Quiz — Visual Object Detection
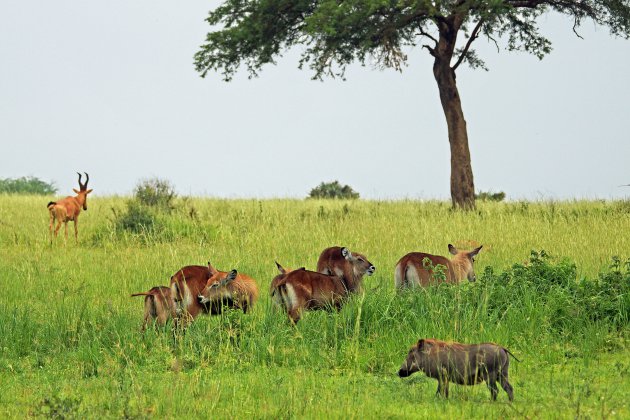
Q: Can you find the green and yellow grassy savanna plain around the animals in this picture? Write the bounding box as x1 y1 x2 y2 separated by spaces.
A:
0 195 630 418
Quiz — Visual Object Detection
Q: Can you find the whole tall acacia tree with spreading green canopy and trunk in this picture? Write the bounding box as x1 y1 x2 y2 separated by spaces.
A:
195 0 630 208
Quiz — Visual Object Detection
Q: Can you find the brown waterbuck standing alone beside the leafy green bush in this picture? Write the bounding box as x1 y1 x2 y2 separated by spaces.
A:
394 244 483 289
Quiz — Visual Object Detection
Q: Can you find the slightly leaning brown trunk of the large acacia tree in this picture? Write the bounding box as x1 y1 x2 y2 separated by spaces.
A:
431 16 475 210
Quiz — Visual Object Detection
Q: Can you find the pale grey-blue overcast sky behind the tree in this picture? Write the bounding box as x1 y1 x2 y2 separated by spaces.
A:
0 0 630 200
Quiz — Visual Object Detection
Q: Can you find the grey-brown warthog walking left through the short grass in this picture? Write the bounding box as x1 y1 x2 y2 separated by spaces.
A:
398 338 518 401
